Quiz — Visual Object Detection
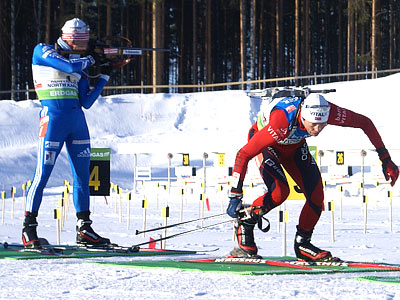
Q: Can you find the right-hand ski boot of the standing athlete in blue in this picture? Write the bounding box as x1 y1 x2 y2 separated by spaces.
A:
76 211 111 246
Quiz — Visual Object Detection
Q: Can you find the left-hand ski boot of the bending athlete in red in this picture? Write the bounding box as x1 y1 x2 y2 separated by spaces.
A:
231 209 262 258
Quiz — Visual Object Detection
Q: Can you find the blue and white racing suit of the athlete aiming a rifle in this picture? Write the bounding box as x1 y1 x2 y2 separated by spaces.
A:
25 44 109 212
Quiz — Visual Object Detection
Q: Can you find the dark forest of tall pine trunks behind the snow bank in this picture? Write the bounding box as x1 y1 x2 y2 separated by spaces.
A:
0 0 400 100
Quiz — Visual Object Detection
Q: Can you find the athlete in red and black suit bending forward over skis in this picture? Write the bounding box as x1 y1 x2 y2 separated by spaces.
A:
227 88 399 261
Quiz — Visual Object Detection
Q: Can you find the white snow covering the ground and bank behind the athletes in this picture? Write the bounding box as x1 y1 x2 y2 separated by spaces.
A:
0 74 400 299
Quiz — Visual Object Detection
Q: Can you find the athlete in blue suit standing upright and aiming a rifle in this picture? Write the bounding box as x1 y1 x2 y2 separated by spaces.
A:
22 18 110 248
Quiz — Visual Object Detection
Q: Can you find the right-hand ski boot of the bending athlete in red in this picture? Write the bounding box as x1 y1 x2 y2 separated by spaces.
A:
294 226 338 262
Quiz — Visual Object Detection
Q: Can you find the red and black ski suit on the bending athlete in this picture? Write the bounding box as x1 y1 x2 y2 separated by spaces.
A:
232 97 384 236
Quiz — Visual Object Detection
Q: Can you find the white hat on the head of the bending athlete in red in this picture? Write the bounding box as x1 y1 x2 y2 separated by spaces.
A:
301 93 331 123
